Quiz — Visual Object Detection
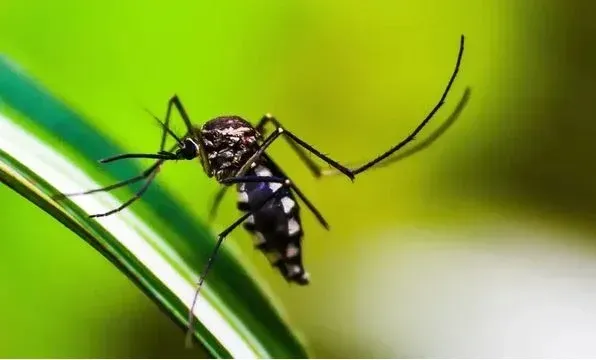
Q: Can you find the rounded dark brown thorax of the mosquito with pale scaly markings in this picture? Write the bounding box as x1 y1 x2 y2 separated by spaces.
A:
201 116 260 180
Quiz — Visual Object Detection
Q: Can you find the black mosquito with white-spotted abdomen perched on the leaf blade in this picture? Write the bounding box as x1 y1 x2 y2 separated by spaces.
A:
54 35 464 344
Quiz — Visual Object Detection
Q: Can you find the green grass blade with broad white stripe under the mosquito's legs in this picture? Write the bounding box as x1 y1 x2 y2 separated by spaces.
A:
0 59 307 358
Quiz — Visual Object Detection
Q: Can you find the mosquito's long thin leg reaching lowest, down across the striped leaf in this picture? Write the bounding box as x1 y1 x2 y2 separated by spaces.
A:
186 178 291 347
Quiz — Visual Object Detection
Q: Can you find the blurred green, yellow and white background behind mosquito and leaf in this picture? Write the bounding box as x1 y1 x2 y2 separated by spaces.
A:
0 0 596 357
